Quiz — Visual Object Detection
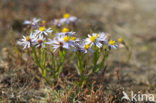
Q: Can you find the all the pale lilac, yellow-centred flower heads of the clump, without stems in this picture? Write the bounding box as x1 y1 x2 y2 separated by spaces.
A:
17 13 122 53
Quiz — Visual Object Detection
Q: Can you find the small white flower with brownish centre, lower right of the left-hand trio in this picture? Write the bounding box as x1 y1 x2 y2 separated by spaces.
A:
33 35 46 47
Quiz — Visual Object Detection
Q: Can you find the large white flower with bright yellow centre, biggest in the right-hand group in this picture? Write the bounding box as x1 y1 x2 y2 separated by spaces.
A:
85 33 102 48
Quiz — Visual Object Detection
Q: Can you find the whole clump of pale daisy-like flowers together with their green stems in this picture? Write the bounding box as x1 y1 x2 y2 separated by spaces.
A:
17 13 125 81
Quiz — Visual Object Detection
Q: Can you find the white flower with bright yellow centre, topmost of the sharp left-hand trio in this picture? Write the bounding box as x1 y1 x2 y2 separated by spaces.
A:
35 26 53 36
